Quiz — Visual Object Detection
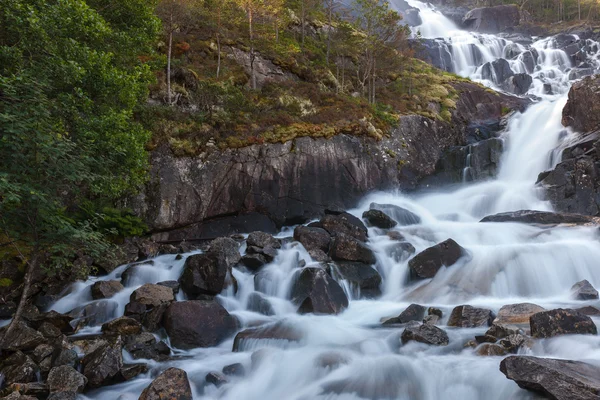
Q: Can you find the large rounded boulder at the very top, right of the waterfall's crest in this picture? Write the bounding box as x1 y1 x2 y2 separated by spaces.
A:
463 4 521 33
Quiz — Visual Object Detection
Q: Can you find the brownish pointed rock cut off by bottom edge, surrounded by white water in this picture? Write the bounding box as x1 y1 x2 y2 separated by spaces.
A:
139 368 193 400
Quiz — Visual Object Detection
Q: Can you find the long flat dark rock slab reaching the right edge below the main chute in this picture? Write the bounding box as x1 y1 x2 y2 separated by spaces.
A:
480 210 600 225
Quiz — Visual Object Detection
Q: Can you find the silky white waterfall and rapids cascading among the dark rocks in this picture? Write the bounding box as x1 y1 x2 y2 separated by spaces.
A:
53 1 600 400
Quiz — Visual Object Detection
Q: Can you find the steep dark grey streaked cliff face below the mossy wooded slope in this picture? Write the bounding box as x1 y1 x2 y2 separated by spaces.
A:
135 83 526 241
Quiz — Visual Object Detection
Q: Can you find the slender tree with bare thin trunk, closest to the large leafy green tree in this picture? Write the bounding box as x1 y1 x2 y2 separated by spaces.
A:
156 0 195 105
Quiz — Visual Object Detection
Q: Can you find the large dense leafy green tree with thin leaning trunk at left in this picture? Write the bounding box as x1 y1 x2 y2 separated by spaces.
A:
0 0 159 349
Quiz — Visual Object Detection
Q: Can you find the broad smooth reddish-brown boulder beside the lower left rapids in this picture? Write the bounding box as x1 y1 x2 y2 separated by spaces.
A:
163 300 238 349
